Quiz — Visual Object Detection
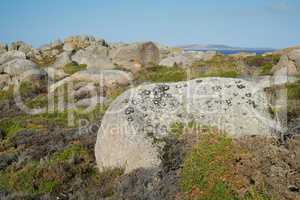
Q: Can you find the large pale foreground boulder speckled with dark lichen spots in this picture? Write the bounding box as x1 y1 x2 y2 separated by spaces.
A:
95 78 279 172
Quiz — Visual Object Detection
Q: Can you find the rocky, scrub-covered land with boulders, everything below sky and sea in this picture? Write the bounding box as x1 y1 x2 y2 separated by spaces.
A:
0 36 300 200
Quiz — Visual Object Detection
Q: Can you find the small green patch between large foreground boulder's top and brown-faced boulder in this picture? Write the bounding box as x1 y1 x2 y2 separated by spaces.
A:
136 66 187 82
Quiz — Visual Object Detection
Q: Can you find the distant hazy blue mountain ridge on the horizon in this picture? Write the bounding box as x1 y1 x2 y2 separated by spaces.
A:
176 44 275 51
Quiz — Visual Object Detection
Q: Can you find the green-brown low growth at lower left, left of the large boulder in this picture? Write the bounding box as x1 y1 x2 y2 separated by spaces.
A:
0 144 92 197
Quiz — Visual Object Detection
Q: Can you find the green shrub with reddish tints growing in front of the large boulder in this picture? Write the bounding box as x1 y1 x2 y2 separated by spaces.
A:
180 134 235 200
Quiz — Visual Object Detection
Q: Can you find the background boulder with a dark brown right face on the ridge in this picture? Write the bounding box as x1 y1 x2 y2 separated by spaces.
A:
112 42 160 69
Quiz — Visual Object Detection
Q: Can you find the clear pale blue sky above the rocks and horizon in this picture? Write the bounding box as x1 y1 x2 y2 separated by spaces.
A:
0 0 300 48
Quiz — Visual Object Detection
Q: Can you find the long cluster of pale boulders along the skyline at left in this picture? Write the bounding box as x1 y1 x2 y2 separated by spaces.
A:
0 35 216 90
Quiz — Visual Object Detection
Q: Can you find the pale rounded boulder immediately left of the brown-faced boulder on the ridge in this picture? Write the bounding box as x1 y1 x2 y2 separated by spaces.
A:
72 45 115 69
